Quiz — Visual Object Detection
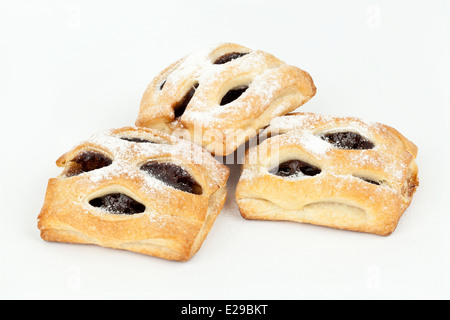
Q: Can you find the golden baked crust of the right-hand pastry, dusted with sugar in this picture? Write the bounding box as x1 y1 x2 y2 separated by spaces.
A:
236 113 419 235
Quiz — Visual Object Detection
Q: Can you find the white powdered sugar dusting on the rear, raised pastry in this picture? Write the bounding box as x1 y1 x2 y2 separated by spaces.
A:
141 44 297 127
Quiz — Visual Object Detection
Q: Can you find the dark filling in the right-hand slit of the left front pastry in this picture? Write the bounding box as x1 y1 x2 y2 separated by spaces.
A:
141 161 203 194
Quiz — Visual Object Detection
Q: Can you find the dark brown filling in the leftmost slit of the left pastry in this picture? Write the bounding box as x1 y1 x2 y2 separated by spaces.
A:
66 151 112 177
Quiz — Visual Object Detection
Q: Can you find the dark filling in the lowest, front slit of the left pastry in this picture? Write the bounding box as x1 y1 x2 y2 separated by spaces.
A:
89 193 145 214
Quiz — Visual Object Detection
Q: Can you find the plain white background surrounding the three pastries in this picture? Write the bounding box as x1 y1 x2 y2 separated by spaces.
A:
0 0 450 299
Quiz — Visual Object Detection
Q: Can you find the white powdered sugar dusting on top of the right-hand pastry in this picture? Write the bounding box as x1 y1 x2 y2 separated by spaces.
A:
243 113 411 192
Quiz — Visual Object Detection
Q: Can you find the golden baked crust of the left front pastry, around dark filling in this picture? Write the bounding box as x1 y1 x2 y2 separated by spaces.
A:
38 127 229 261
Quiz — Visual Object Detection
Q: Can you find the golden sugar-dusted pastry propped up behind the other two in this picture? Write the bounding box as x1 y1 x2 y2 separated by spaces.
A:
136 43 316 156
